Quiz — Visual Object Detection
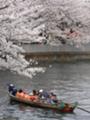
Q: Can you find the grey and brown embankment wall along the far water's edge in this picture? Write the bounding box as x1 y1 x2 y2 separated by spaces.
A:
22 44 90 62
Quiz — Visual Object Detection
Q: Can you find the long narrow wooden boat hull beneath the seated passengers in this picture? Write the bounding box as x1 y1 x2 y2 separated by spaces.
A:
9 94 77 113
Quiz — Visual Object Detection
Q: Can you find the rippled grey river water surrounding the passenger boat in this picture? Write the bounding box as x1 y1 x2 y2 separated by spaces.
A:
0 61 90 120
